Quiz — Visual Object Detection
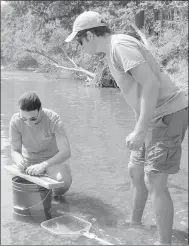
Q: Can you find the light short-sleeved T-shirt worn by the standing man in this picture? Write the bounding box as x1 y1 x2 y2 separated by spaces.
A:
108 34 188 120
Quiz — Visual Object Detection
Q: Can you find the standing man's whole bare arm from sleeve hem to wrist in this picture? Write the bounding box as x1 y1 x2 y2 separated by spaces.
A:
130 63 160 133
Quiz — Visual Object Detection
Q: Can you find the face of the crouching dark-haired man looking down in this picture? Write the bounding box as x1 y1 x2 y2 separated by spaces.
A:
20 109 40 126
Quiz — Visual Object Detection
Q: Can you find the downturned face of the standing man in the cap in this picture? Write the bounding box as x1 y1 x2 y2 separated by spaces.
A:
77 32 97 54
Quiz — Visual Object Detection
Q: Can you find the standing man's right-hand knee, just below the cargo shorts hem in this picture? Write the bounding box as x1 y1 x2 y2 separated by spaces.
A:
144 173 168 196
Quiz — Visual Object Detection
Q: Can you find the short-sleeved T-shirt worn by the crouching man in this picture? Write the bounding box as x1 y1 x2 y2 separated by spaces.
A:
9 108 67 163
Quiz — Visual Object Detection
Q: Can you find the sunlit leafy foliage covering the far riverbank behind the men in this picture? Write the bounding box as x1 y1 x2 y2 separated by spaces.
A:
1 1 188 91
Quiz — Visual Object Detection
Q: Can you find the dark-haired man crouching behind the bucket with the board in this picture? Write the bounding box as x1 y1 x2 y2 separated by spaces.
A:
9 92 72 197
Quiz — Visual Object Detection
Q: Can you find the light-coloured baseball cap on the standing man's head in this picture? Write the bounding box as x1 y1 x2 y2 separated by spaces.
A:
65 11 107 42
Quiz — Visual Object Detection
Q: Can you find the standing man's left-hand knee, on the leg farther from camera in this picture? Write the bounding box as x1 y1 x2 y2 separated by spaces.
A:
128 162 144 186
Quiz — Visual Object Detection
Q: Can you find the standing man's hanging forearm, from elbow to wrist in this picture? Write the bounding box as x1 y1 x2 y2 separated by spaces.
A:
135 84 159 132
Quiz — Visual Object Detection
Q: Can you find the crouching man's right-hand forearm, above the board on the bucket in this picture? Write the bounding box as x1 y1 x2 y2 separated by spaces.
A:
44 151 71 168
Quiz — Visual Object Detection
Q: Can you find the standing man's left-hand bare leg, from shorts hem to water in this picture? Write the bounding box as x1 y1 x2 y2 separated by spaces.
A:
128 162 148 224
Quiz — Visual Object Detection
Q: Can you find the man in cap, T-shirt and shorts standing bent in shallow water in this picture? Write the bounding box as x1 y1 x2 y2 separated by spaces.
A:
65 11 188 245
